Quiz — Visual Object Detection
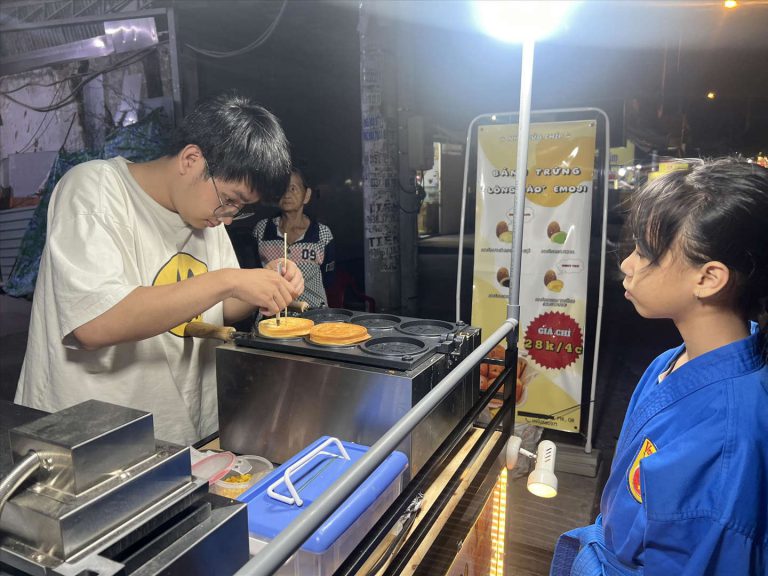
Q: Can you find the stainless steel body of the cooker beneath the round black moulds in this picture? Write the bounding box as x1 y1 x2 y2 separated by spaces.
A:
216 328 479 476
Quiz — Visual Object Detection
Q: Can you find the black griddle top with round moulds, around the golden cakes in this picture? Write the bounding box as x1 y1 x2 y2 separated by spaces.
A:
235 308 458 370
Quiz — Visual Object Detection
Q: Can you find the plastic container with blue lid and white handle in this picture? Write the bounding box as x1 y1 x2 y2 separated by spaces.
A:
238 436 408 576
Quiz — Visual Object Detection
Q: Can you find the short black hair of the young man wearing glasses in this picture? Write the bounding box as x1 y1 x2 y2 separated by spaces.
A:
168 92 291 204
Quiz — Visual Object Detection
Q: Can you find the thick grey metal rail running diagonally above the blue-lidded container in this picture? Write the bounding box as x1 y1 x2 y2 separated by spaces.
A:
237 319 517 576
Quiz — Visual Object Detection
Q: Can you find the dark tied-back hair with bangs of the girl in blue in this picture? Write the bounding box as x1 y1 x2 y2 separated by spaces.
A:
628 158 768 329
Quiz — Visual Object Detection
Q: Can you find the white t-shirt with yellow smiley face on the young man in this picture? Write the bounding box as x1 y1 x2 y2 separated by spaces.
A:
15 157 238 445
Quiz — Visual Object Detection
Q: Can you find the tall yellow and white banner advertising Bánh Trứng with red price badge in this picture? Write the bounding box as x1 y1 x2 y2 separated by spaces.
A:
472 120 597 432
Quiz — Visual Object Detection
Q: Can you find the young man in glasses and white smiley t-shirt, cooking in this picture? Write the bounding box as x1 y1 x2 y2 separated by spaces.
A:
16 95 304 444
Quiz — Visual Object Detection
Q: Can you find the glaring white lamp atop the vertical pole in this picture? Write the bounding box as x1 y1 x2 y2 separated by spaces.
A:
473 0 577 43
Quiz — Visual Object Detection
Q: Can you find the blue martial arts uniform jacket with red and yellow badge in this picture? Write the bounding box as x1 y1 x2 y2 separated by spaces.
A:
553 334 768 576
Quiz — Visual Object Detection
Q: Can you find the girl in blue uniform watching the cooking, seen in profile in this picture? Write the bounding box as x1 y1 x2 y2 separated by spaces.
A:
551 159 768 576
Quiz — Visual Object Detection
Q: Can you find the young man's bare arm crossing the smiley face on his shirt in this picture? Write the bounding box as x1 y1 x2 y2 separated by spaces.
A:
73 269 296 350
